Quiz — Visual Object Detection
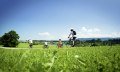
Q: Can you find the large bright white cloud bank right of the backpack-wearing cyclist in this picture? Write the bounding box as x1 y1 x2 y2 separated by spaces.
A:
77 27 120 38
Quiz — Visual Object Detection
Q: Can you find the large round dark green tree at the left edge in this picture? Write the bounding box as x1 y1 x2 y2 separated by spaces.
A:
1 30 19 47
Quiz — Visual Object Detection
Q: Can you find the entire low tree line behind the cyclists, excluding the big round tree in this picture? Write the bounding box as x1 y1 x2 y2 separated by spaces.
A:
29 38 120 47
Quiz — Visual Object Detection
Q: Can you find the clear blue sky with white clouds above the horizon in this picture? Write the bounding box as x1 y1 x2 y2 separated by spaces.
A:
0 0 120 40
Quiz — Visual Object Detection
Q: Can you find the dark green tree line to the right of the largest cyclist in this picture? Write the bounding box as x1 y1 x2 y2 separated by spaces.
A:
76 38 120 47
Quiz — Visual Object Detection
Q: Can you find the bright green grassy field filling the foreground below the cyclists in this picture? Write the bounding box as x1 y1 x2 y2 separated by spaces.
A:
0 45 120 72
